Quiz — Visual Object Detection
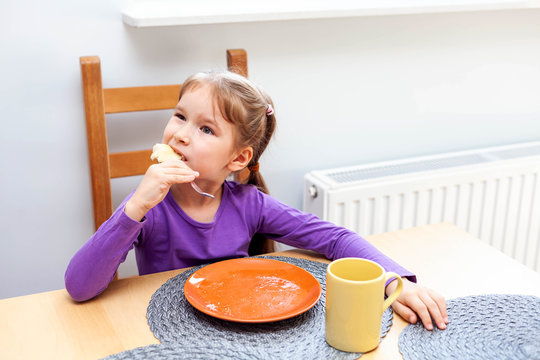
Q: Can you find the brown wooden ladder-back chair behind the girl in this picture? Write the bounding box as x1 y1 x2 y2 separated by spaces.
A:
80 49 273 262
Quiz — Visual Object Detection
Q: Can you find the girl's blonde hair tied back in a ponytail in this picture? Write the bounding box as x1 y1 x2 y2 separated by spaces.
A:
179 71 276 194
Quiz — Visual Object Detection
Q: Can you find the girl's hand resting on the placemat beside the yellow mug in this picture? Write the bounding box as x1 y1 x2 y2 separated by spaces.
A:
386 278 448 330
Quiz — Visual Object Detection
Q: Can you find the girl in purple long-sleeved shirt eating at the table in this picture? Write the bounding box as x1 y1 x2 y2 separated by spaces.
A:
65 72 448 329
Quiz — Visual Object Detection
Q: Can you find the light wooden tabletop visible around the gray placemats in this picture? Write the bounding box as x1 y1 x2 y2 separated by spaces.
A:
0 223 540 360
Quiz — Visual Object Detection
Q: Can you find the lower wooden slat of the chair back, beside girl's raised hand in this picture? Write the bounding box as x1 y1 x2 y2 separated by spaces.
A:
109 150 154 178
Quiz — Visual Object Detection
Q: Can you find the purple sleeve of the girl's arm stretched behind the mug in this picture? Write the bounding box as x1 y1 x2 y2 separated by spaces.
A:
258 192 416 282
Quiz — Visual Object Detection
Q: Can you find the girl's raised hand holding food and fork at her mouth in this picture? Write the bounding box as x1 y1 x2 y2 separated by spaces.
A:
124 160 199 221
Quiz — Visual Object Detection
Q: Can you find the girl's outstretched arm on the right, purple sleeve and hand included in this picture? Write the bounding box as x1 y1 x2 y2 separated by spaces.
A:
255 193 448 330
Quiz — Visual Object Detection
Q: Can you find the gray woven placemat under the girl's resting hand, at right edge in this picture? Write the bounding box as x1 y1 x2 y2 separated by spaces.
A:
399 294 540 360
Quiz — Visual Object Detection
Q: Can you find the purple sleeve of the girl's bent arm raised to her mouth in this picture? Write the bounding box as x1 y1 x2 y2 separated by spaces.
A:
64 197 146 301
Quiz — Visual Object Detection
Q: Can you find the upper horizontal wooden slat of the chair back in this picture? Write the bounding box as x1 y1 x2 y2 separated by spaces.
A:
103 84 182 114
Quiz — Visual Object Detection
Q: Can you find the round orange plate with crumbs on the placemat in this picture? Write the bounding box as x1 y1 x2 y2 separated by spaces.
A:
184 258 321 323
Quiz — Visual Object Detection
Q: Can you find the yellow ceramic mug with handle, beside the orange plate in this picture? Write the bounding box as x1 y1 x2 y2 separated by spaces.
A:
326 258 403 352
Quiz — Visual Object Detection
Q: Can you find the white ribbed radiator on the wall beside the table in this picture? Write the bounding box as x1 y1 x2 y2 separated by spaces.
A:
304 142 540 271
